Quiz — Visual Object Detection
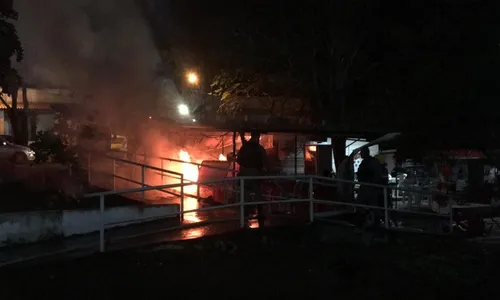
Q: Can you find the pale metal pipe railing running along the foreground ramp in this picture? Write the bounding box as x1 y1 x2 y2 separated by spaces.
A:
86 173 453 252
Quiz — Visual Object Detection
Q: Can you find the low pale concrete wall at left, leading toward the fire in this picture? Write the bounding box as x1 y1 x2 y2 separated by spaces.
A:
0 204 179 247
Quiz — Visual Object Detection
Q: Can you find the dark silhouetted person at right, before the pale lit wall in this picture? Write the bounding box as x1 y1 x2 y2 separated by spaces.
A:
356 147 384 226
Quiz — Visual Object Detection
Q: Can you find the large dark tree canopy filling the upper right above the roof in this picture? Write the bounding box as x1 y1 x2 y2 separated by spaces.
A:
150 0 500 163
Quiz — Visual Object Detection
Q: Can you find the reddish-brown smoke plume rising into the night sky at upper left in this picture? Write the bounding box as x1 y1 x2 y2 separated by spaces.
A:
15 0 160 128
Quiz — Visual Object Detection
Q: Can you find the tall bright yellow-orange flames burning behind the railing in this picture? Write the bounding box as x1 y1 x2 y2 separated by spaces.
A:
179 150 200 222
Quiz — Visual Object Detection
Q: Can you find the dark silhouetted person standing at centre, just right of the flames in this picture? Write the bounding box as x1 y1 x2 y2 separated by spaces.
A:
237 132 268 227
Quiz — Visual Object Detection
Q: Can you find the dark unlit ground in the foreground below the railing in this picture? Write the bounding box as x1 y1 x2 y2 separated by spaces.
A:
0 226 500 300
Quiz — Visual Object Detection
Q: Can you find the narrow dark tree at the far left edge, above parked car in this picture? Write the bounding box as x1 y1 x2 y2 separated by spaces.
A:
0 0 27 143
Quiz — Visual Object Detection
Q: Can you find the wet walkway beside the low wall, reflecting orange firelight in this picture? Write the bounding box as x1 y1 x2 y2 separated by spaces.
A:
0 209 298 267
